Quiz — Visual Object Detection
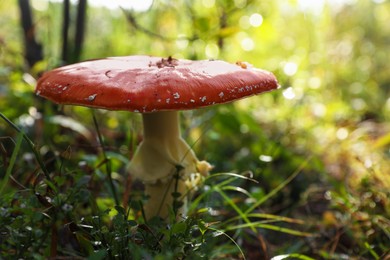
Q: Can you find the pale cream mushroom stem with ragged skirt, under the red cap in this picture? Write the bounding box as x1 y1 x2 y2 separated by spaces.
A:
129 111 208 218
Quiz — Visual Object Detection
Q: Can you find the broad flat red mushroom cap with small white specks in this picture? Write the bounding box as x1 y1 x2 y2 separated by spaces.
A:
36 56 278 113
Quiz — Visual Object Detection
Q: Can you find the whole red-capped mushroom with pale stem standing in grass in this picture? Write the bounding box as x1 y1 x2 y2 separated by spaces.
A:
36 56 278 218
